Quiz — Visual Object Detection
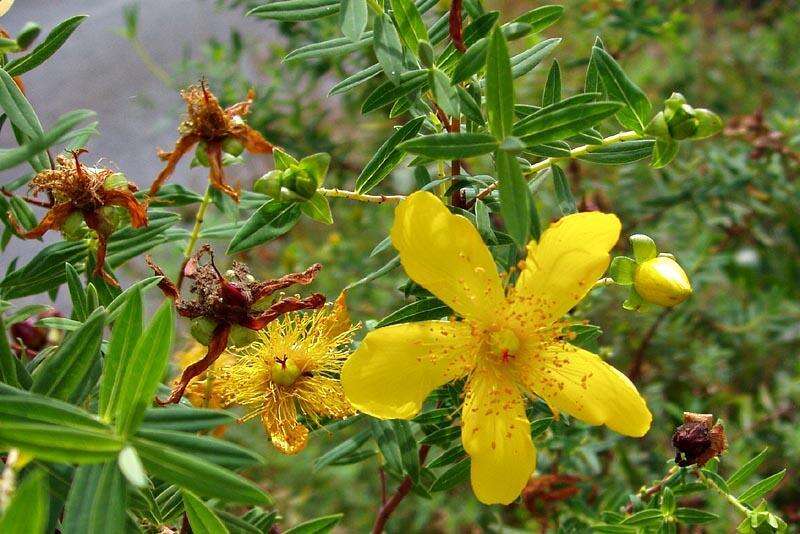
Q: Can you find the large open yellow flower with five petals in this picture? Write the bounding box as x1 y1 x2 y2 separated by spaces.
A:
342 192 652 504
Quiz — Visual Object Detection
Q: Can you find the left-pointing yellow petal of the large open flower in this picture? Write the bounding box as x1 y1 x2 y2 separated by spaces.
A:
342 321 478 419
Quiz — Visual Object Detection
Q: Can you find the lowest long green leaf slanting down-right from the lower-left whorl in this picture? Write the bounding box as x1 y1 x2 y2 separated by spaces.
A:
131 438 272 505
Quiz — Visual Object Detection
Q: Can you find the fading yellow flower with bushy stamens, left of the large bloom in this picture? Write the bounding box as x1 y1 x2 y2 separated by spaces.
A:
218 298 358 454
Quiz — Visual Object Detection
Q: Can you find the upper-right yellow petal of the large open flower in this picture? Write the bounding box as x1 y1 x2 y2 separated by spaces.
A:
515 212 620 321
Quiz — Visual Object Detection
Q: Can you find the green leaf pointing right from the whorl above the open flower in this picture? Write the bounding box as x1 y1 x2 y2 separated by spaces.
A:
513 95 620 146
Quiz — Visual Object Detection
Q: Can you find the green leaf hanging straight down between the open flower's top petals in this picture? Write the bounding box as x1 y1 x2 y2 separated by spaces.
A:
495 150 531 248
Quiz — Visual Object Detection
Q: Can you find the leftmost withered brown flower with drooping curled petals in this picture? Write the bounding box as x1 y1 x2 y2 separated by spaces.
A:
9 149 147 285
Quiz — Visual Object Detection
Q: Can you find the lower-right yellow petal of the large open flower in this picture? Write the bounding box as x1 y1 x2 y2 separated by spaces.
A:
519 343 653 437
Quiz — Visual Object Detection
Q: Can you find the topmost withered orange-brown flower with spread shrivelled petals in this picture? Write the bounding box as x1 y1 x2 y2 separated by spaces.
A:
150 81 273 201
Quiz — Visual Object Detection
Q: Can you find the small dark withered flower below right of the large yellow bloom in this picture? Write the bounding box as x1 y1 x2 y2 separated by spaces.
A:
672 412 728 467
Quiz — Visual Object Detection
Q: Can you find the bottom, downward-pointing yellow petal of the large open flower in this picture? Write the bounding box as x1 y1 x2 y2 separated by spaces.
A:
461 368 536 504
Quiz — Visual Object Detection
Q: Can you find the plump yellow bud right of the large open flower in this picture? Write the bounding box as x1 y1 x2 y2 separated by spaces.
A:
633 255 692 307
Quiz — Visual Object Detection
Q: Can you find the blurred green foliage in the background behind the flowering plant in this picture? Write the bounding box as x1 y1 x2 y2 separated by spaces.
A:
112 0 800 532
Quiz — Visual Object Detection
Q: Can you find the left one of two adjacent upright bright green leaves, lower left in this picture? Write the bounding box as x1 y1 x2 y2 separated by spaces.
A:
98 290 144 421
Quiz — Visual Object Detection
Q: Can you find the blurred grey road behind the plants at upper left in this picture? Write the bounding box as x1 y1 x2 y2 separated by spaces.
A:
0 0 269 280
